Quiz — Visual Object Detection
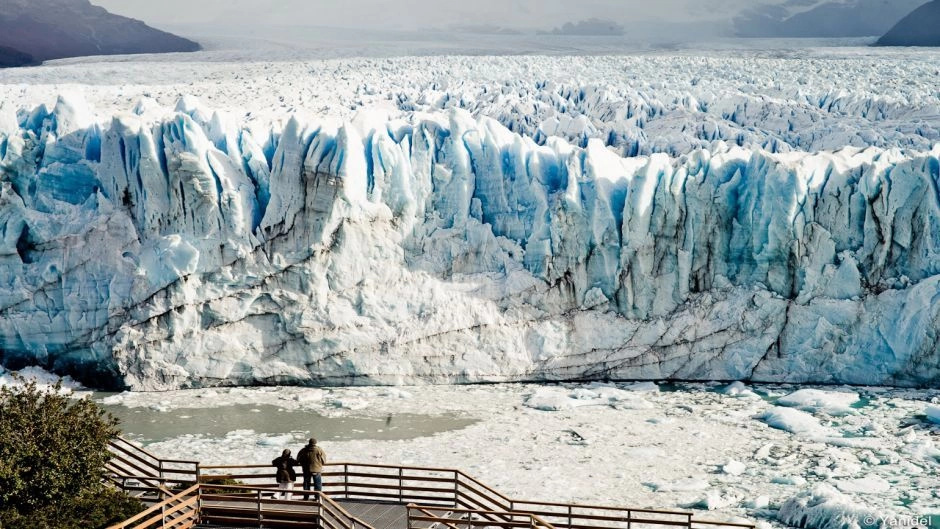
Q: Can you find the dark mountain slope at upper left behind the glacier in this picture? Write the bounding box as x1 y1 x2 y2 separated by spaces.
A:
0 0 200 66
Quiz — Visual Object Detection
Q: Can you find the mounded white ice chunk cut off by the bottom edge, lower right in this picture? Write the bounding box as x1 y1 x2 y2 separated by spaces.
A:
777 484 882 529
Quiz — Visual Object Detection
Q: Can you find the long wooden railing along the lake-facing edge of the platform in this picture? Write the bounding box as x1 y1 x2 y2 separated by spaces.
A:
108 440 754 529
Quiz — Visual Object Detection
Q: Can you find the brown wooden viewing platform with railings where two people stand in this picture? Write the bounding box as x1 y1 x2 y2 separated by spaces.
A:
106 439 754 529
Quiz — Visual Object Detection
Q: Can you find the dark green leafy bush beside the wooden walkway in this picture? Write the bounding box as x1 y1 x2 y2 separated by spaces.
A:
0 374 142 529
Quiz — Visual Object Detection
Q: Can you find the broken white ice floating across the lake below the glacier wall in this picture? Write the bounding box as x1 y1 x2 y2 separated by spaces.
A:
0 370 940 529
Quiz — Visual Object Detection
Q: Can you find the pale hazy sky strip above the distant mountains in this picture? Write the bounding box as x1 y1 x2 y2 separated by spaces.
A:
92 0 784 29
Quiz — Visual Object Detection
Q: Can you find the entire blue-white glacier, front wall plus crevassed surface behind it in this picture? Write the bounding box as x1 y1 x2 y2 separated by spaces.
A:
0 50 940 390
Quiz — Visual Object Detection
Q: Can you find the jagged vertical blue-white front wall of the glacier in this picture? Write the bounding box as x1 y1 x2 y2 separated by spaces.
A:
0 97 940 390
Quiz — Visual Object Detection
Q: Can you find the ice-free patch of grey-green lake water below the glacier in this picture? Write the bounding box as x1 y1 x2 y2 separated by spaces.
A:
96 394 477 444
